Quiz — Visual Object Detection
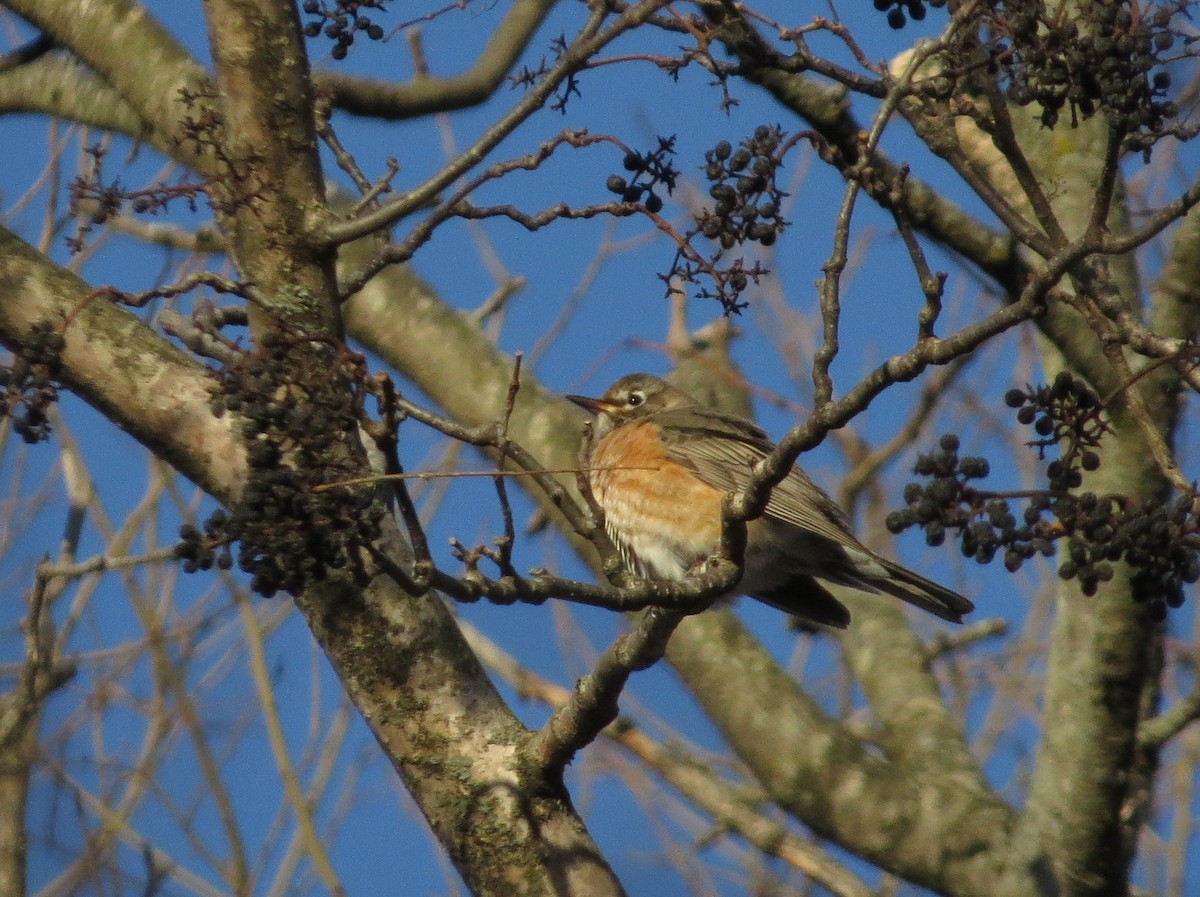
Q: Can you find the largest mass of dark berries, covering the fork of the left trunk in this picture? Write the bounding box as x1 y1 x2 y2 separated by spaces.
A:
179 335 384 596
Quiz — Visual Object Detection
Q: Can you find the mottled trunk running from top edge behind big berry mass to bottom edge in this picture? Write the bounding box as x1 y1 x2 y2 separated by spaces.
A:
193 0 620 897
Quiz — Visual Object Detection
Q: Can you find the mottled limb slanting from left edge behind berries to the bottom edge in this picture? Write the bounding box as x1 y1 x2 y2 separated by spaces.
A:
0 182 620 895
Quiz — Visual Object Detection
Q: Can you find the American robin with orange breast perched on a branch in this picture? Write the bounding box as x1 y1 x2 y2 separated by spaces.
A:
566 374 974 628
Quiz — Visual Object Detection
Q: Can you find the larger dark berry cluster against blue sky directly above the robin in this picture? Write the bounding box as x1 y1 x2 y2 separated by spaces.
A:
696 125 787 249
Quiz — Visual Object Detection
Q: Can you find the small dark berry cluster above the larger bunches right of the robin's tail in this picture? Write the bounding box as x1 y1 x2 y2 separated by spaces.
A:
1004 371 1109 493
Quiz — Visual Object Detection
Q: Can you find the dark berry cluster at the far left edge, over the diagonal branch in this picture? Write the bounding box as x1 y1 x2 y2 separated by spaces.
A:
0 321 66 445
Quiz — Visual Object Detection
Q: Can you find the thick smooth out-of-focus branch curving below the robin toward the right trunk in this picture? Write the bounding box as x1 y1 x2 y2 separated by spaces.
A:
667 610 1014 895
